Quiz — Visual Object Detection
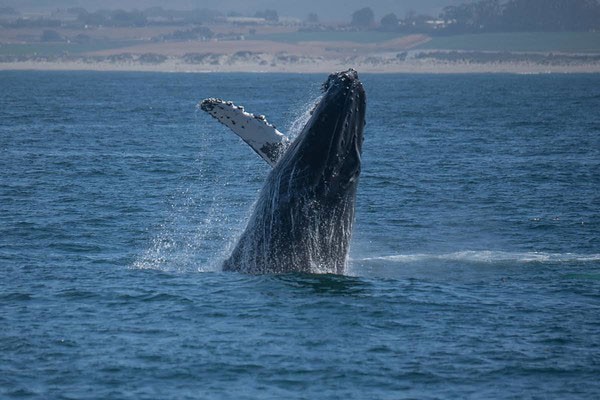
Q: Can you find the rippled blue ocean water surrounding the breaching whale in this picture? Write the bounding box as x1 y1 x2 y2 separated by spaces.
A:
0 72 600 399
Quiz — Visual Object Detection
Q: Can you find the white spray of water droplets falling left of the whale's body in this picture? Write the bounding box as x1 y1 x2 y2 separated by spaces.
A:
132 115 255 272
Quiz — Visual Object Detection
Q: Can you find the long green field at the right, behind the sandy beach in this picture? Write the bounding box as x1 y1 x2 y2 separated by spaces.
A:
416 32 600 53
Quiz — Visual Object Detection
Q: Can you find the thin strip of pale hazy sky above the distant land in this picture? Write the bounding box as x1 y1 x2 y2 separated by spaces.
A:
0 0 466 21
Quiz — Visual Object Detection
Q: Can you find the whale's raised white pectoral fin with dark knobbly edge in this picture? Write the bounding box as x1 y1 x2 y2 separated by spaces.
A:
200 98 289 166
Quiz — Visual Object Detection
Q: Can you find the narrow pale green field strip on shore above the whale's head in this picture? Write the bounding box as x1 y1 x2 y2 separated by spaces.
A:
248 31 406 43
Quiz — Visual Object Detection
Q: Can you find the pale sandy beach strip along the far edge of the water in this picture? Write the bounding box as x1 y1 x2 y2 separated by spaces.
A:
0 54 600 74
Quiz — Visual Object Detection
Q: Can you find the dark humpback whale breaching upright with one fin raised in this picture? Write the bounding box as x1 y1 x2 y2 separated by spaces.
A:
200 69 366 274
